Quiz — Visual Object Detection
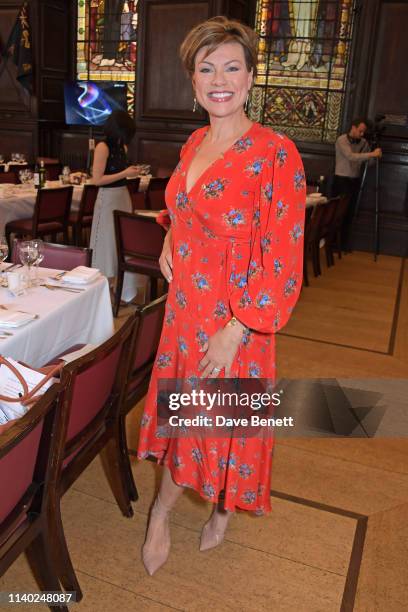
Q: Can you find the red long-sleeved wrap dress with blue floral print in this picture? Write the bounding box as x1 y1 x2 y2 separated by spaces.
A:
138 123 306 514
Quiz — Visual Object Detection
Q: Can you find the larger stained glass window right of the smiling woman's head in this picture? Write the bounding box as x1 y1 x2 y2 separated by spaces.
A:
250 0 354 142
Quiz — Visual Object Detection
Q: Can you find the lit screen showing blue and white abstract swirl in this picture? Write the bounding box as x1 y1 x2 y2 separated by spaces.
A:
64 81 127 125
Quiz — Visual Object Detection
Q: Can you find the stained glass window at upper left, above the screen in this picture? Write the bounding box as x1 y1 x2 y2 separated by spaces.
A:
77 0 137 114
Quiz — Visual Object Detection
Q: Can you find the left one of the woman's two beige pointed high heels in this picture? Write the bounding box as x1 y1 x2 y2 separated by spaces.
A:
142 495 170 576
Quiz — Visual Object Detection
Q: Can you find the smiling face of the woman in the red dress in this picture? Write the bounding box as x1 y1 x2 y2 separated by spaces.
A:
192 42 252 117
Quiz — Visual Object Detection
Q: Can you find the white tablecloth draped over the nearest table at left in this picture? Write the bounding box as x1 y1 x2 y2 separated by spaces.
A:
0 268 114 367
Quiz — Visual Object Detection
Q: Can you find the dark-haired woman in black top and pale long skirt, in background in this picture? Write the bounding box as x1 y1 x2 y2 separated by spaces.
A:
89 111 138 279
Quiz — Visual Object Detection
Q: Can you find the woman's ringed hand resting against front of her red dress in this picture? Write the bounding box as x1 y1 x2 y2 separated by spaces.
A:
198 323 244 378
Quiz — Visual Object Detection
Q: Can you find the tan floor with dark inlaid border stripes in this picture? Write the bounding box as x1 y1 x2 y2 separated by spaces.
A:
0 253 408 612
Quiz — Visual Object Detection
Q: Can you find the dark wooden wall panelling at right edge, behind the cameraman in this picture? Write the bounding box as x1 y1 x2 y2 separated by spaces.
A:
354 0 408 255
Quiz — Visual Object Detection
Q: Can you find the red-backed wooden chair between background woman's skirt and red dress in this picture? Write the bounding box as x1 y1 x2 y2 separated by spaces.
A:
113 210 166 316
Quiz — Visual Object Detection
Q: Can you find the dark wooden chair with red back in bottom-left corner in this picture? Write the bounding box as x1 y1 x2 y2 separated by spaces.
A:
0 384 68 612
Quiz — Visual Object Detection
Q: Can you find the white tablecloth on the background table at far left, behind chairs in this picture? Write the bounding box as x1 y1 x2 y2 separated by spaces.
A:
0 181 83 234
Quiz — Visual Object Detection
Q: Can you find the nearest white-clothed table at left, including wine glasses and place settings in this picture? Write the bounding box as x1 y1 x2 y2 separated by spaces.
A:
0 238 114 367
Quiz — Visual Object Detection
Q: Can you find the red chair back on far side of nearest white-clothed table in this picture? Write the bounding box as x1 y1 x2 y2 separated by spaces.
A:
11 238 92 271
